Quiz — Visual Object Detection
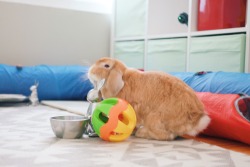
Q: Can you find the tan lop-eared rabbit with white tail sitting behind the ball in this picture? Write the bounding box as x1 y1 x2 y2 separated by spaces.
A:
88 58 210 140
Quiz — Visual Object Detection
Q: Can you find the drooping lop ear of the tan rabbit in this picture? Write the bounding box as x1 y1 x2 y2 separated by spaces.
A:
105 70 124 96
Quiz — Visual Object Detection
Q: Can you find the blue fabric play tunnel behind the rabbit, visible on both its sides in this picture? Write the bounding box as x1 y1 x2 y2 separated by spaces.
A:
0 64 250 100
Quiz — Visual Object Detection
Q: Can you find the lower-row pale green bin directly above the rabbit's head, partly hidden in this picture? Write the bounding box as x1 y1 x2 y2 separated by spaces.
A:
114 41 144 69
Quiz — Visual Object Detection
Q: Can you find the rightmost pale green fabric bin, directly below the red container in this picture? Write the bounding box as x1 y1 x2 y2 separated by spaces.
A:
189 34 246 72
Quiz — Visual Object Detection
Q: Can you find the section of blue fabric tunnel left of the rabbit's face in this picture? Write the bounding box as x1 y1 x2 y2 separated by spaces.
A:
0 64 92 100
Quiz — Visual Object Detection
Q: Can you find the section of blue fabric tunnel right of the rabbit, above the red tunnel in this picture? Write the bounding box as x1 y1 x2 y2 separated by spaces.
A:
170 72 250 95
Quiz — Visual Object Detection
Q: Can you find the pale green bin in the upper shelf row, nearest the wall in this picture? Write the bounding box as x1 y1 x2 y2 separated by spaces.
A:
115 0 147 38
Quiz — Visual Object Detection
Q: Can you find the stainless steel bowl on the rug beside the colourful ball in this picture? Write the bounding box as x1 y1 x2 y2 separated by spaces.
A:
50 116 90 139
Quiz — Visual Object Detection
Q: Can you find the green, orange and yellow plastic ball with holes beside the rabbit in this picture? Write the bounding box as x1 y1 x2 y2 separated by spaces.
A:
92 98 136 142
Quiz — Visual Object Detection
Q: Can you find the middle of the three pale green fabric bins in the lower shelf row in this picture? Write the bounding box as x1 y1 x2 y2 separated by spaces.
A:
147 38 187 72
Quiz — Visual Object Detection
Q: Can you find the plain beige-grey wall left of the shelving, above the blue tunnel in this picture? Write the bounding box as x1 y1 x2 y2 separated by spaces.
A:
0 1 111 65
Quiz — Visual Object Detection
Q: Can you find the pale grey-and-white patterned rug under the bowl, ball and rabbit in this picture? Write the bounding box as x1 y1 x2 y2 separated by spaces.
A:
0 106 250 167
